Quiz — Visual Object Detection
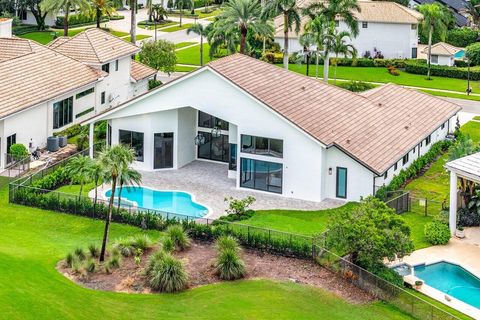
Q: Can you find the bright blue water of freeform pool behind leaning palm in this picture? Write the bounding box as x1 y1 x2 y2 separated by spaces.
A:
105 187 208 217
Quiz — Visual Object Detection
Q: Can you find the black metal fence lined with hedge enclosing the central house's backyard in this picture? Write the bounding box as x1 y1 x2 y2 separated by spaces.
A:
9 162 458 320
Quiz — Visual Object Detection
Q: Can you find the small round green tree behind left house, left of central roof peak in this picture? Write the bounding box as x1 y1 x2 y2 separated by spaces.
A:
138 40 177 74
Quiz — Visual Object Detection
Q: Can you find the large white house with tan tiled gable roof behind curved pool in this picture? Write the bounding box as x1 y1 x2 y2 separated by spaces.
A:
83 54 460 201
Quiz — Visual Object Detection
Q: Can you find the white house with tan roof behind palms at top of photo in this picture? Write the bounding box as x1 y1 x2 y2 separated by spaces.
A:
275 0 422 59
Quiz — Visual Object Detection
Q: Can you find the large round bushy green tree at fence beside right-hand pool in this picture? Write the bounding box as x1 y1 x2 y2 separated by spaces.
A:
327 197 413 271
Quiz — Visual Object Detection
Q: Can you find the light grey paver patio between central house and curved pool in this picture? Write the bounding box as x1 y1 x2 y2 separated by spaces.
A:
94 160 345 219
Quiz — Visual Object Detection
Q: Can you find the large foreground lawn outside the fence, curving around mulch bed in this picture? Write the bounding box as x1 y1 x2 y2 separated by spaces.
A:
0 188 411 320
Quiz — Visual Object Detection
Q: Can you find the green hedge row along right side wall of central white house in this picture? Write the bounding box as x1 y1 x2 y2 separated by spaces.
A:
375 140 452 200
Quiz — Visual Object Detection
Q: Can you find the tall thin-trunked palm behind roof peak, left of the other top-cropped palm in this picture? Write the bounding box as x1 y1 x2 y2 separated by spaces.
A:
263 0 301 70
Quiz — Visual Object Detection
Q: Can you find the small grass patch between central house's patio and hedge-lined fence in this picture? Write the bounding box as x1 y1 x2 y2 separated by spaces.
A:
241 202 357 235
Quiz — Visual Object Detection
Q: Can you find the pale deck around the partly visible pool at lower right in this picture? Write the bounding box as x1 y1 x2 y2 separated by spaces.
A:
388 228 480 319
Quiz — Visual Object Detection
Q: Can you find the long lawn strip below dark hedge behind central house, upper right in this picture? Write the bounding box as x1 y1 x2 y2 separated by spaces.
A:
284 63 480 93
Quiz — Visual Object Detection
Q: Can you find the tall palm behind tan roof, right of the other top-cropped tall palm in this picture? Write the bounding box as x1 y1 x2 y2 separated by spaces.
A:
304 0 360 82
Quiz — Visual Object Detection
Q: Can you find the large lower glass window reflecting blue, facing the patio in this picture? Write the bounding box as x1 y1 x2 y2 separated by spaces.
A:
240 158 283 193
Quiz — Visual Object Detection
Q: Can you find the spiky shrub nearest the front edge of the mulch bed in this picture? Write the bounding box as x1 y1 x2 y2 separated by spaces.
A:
148 254 188 292
